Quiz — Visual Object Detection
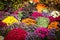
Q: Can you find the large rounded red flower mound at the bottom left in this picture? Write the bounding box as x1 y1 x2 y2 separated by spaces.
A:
4 28 27 40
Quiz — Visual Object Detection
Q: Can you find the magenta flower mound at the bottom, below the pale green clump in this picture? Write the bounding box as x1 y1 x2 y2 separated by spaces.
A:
34 27 48 38
